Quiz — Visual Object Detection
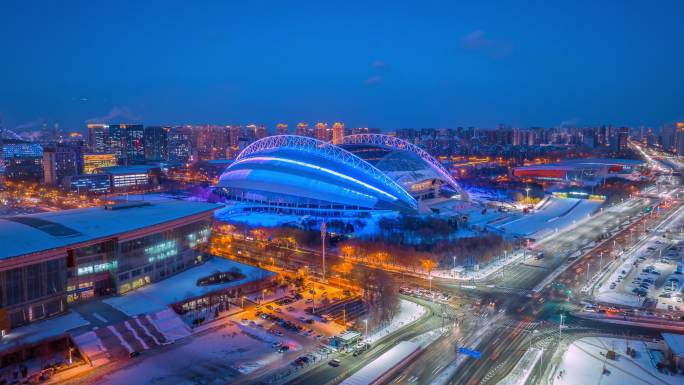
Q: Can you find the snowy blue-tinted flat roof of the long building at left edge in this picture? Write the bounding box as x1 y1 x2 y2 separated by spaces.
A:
0 200 221 260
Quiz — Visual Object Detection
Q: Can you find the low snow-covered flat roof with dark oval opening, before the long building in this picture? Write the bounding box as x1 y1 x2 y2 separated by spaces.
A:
105 257 275 316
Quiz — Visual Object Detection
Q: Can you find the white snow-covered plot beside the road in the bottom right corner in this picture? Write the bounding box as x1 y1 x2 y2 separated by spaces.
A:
553 337 684 385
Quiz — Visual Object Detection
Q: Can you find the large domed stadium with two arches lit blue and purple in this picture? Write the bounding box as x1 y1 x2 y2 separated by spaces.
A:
217 134 468 216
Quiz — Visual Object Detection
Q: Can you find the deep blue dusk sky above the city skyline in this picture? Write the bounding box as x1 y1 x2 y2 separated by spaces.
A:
0 0 684 130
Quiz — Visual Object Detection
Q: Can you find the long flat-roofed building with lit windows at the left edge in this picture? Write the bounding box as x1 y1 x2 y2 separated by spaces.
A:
0 200 218 332
